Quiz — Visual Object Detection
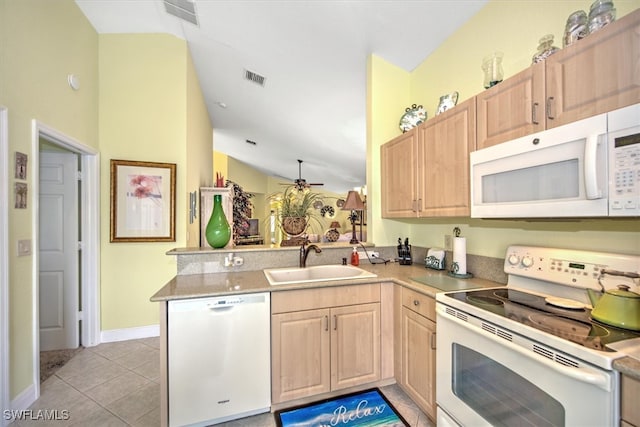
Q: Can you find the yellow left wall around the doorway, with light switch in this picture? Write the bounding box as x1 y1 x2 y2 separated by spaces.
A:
0 0 98 399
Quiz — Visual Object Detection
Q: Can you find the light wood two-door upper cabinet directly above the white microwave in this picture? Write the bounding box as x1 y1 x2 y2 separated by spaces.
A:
476 9 640 149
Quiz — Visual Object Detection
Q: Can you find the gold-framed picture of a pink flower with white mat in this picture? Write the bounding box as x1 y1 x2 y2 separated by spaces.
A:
110 159 176 243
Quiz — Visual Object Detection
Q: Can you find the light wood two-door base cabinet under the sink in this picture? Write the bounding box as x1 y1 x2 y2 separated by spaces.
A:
271 285 381 403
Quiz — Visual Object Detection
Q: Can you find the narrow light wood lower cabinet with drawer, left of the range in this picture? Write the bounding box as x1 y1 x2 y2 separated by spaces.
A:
399 288 436 420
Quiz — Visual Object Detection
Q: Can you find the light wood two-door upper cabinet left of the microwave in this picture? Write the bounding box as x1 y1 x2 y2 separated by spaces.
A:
380 98 476 218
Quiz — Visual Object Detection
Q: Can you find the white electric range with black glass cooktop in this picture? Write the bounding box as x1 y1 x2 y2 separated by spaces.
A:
436 246 640 426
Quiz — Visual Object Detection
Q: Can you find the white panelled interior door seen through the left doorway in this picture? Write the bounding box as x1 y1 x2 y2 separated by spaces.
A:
39 152 79 351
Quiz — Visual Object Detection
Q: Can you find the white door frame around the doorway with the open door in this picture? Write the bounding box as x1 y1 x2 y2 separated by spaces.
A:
31 119 100 399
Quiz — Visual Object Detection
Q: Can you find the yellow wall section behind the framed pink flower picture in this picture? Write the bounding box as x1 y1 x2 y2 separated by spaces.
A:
99 34 194 330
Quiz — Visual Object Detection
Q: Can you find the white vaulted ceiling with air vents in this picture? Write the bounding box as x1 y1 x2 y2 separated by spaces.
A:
76 0 487 193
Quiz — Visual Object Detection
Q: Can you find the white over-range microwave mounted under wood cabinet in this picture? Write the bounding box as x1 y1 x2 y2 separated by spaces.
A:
470 104 640 218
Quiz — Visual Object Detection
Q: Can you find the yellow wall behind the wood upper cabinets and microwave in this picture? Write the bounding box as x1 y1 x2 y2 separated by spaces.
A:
367 0 640 257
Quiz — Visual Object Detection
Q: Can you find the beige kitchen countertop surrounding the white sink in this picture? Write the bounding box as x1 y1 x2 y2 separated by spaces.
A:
151 263 503 302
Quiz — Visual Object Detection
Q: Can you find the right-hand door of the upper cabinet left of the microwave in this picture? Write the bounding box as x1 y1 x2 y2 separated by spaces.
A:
417 98 476 217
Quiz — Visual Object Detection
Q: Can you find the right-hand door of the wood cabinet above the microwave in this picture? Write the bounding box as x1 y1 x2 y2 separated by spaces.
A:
546 9 640 128
